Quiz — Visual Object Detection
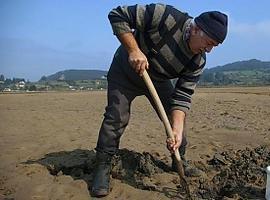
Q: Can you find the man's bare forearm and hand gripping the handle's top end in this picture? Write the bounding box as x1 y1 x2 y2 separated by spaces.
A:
117 33 149 76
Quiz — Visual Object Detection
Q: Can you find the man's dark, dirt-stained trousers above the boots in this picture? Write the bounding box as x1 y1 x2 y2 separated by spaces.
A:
96 48 187 154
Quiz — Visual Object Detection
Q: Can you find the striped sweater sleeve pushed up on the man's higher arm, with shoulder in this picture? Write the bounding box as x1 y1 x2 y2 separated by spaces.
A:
108 4 166 35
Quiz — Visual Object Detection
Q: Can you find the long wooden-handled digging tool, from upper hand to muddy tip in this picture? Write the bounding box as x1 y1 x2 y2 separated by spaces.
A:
142 70 191 199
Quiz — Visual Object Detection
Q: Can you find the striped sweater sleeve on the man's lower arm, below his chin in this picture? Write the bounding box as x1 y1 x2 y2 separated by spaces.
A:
171 55 206 113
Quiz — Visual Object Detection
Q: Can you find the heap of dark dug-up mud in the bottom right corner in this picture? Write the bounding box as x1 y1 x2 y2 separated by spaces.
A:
203 146 270 199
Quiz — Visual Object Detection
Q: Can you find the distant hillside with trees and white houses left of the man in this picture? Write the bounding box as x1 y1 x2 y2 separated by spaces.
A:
0 70 107 92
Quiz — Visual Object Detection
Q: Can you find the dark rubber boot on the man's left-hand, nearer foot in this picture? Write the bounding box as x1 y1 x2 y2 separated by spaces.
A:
91 152 112 197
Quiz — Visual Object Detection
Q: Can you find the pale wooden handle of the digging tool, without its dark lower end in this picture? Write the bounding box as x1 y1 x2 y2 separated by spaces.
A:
142 70 181 161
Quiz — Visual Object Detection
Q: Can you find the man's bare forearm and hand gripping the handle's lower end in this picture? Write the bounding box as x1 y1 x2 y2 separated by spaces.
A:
166 110 185 153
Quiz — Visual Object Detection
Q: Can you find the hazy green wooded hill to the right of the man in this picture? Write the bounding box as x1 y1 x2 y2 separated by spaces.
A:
199 59 270 86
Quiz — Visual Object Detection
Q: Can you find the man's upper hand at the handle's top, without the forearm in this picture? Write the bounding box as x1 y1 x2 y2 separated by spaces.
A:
128 49 149 76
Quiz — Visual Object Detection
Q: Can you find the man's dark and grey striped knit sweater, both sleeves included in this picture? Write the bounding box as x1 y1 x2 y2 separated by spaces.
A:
108 4 206 112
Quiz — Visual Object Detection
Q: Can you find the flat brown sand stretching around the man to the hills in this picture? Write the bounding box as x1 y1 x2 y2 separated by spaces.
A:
0 87 270 200
